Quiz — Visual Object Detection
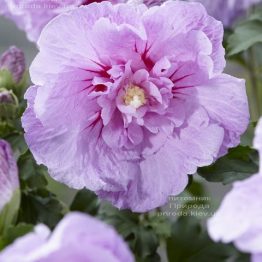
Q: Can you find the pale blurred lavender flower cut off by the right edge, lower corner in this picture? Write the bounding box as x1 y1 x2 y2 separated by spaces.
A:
208 119 262 262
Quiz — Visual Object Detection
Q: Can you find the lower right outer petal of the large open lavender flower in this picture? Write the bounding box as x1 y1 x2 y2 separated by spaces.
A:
98 107 224 212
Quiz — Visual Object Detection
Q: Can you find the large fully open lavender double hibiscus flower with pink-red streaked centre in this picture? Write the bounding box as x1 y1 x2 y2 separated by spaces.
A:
22 1 249 212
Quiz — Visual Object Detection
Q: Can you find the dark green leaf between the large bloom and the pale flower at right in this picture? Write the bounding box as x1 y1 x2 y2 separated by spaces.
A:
197 146 258 184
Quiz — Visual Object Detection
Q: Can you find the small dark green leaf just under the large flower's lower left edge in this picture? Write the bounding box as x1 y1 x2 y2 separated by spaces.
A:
70 189 100 215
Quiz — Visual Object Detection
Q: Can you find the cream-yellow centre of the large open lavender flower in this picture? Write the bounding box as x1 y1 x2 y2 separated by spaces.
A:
124 85 146 109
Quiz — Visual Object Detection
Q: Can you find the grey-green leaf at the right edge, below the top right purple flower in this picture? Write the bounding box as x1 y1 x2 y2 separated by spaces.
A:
228 10 262 56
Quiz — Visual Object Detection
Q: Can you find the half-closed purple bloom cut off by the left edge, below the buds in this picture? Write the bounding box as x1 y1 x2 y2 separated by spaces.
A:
0 139 19 213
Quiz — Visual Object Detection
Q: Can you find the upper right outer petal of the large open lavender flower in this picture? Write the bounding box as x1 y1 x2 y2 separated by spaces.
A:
143 1 225 73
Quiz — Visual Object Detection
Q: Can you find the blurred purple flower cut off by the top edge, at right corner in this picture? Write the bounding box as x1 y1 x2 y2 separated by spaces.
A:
189 0 262 27
